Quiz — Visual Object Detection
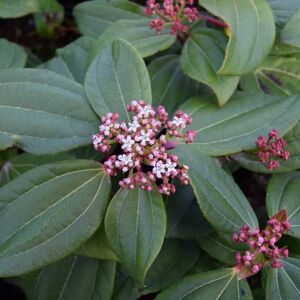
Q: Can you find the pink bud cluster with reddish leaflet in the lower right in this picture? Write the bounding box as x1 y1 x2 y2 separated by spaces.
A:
232 210 290 278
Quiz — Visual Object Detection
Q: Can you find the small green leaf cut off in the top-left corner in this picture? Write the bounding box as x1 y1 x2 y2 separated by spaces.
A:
0 0 40 18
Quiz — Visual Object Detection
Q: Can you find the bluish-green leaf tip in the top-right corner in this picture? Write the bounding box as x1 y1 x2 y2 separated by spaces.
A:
268 0 300 26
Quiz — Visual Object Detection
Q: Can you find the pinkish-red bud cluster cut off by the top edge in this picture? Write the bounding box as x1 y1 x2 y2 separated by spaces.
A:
144 0 199 36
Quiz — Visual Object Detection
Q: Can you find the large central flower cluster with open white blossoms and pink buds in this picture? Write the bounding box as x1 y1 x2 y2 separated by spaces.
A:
93 100 196 195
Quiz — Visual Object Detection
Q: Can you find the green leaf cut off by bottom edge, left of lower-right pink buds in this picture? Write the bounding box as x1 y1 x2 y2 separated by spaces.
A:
155 269 253 300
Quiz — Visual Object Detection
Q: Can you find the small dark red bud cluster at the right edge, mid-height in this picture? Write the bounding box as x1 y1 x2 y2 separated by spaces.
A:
256 129 289 171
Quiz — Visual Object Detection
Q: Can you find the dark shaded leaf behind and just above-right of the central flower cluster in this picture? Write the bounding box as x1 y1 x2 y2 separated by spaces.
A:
148 54 199 113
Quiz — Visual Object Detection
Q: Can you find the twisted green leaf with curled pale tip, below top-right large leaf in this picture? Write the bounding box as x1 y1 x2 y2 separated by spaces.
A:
180 29 239 106
